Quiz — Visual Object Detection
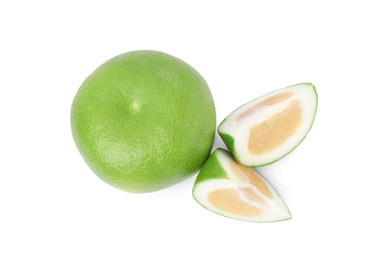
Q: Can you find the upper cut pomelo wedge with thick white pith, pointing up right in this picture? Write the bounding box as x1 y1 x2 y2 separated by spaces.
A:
218 83 317 167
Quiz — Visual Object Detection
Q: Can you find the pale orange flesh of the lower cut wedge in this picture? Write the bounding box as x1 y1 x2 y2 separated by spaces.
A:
207 161 272 217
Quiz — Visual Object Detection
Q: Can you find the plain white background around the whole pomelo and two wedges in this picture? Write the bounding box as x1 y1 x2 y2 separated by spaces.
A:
0 0 390 260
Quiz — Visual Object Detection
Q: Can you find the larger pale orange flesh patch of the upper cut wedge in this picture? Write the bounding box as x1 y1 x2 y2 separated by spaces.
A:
248 100 303 154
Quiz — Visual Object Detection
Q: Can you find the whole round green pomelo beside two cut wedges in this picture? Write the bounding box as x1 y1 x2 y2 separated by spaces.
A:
71 51 216 192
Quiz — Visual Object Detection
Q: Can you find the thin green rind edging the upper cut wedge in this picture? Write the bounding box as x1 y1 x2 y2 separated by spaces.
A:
217 83 318 168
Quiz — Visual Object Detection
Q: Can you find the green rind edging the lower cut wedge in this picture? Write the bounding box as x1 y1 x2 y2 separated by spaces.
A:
192 148 291 223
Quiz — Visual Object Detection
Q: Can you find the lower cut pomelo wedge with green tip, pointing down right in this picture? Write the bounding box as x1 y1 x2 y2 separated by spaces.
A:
192 148 291 222
